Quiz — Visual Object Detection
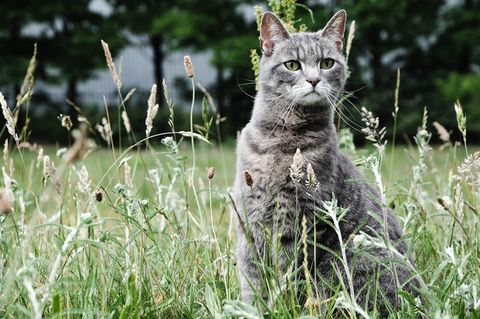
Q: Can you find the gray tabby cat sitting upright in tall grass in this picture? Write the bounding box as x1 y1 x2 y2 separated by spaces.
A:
234 10 413 312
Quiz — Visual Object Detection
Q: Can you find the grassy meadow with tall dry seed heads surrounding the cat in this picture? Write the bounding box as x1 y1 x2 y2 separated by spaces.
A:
0 46 480 319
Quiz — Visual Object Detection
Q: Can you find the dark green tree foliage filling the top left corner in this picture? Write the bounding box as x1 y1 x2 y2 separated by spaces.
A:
0 0 123 106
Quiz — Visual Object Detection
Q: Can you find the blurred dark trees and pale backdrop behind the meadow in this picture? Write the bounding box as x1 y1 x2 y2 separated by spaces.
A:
0 0 480 143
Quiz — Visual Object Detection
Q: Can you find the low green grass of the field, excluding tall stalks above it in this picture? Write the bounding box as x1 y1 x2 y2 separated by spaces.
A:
0 132 479 318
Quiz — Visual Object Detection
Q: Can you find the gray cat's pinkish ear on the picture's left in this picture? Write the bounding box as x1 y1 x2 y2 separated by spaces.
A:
260 12 290 56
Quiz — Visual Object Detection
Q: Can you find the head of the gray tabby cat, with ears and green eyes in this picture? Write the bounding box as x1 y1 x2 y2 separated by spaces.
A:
260 10 347 111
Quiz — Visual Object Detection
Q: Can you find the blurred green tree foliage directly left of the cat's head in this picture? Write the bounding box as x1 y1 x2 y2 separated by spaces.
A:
110 0 257 134
